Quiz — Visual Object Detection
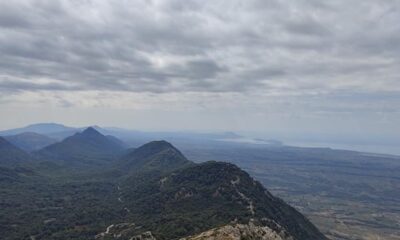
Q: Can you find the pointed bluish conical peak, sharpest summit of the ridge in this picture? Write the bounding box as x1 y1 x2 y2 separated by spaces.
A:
36 127 124 164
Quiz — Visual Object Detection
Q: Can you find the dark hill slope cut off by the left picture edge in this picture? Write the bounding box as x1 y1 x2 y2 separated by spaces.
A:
0 137 31 166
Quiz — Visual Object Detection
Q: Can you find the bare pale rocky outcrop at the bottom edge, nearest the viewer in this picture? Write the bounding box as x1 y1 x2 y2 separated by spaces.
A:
181 222 293 240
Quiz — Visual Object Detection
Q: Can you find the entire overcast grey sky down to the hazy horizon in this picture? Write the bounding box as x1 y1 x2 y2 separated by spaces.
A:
0 0 400 146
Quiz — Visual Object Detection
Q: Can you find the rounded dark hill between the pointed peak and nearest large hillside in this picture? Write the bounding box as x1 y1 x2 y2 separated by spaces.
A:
119 141 192 172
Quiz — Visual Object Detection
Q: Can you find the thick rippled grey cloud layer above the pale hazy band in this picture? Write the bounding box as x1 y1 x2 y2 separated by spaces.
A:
0 0 400 94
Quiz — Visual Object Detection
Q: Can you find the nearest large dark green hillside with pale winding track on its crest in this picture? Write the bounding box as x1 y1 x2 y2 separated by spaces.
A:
115 162 326 240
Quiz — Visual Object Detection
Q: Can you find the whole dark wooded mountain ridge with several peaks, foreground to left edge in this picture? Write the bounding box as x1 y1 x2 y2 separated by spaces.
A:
0 127 326 240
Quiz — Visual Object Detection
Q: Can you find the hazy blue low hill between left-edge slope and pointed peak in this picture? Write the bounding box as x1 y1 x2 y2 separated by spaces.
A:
4 132 57 152
